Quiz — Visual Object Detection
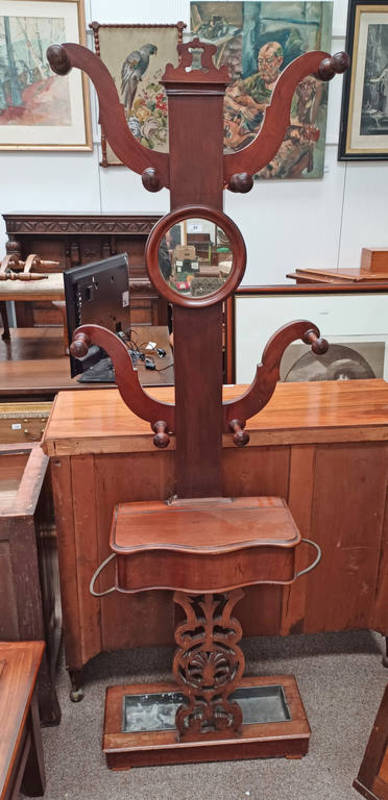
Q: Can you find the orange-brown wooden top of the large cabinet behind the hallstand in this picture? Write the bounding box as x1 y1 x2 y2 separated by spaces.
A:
43 379 388 455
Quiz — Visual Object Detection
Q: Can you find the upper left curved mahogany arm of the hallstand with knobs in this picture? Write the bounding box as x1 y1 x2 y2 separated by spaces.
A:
47 43 169 191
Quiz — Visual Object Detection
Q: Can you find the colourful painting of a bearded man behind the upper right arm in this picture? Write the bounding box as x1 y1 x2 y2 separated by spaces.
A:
191 0 333 179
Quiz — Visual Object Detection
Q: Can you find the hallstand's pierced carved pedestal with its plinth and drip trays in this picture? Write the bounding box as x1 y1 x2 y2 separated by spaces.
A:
103 589 310 770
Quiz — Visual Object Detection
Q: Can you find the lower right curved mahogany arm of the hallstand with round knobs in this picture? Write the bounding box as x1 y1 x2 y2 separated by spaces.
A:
223 320 329 446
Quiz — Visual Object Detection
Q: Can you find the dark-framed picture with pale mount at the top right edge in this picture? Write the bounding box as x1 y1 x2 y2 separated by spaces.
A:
338 0 388 161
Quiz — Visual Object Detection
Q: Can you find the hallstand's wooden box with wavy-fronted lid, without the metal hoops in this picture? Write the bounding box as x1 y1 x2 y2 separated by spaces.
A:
110 497 300 594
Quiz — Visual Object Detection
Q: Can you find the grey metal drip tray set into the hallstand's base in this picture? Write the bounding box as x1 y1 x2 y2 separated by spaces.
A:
121 684 291 733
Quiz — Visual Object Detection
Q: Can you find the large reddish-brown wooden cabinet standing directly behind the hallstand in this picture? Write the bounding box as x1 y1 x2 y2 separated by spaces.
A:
43 380 388 696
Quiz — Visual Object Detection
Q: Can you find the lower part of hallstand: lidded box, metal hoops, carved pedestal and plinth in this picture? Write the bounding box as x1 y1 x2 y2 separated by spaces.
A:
90 497 320 769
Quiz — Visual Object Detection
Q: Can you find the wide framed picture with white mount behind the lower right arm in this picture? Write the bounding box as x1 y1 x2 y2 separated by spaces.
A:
226 286 388 384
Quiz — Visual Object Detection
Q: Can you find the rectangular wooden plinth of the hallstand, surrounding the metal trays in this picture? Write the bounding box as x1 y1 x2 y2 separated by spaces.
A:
103 675 311 770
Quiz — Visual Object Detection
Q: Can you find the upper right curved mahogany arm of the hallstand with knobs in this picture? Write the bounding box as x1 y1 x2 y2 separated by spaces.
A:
224 50 349 192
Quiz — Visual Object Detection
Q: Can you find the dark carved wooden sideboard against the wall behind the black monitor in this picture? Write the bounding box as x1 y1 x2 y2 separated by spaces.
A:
3 214 167 327
